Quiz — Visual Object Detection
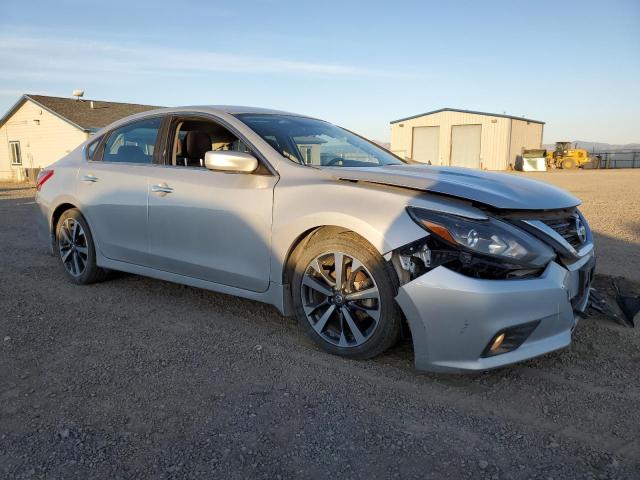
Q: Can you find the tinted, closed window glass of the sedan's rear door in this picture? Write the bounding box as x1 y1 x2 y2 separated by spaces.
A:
102 117 162 163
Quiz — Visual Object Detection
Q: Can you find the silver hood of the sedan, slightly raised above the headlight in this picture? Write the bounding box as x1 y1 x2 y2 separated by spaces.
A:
327 164 581 210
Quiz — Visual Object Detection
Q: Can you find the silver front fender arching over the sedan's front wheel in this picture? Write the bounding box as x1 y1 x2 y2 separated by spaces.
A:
271 177 486 283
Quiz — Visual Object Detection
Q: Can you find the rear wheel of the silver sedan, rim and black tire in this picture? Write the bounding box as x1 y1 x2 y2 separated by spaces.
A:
55 208 107 285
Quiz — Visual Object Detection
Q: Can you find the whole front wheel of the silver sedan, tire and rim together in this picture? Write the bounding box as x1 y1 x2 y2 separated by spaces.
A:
292 232 400 359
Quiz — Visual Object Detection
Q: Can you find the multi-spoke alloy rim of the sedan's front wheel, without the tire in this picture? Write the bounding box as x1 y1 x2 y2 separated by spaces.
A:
301 252 381 347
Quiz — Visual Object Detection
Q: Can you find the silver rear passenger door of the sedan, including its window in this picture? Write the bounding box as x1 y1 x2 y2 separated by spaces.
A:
78 117 162 265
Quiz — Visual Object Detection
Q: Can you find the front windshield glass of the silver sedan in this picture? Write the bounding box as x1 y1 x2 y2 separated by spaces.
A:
236 113 403 167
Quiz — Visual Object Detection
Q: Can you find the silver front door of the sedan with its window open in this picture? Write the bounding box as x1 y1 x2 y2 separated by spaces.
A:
148 115 278 292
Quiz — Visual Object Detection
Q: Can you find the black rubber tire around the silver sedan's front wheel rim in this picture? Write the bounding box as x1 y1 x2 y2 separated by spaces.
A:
291 230 401 359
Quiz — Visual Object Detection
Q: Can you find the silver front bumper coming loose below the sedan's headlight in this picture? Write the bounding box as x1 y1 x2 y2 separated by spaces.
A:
396 253 595 373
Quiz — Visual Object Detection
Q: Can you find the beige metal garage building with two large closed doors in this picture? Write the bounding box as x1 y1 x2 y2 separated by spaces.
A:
391 108 544 170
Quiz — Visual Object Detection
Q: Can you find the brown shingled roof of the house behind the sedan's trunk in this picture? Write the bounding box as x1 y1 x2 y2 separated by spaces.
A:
0 94 163 132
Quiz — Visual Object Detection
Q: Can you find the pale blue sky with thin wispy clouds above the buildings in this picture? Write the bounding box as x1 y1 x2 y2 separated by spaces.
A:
0 0 640 143
